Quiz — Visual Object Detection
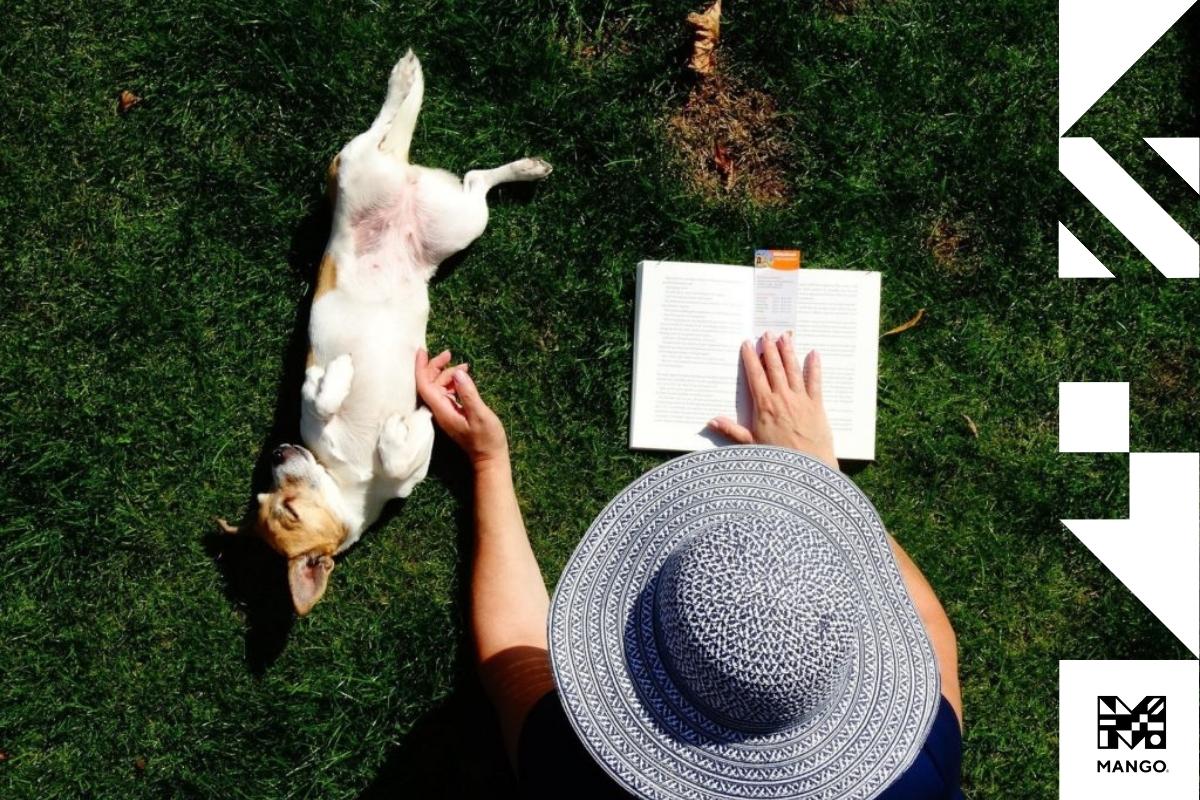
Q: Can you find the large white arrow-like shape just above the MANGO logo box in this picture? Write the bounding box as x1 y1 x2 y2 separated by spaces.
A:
1062 452 1200 656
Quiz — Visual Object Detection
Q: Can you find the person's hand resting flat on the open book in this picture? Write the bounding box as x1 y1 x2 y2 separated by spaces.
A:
708 332 838 469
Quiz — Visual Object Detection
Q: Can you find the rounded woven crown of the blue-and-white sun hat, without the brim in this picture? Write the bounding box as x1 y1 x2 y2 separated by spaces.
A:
654 515 865 733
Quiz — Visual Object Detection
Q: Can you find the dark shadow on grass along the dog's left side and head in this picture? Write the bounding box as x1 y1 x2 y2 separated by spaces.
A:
204 190 330 676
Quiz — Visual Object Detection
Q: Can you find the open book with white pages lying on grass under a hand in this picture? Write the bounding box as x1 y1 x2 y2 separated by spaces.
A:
629 261 880 461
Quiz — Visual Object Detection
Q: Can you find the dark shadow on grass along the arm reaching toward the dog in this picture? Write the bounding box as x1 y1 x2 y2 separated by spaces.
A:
359 431 517 800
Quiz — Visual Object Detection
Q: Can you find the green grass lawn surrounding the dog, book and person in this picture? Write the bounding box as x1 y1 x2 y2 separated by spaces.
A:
0 0 1200 799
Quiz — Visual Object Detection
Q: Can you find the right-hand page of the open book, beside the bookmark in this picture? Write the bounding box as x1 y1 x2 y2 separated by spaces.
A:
782 270 880 461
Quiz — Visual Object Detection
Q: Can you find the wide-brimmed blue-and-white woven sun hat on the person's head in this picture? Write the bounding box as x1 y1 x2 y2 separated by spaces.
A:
548 446 941 800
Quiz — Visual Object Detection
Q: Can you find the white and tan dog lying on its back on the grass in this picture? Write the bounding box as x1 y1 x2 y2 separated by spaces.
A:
222 50 551 614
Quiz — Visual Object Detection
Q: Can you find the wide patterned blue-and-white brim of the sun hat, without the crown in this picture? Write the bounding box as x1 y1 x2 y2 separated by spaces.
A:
548 446 941 800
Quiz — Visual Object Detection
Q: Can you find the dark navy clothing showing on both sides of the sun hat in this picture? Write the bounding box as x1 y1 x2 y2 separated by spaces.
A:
517 692 962 800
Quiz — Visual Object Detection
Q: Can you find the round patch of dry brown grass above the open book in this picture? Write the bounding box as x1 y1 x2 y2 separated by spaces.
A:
667 71 792 205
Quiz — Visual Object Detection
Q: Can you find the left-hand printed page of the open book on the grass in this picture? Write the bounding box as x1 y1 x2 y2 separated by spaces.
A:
629 261 754 451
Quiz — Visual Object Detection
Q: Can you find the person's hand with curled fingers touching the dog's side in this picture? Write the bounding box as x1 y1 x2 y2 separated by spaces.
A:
416 349 509 468
